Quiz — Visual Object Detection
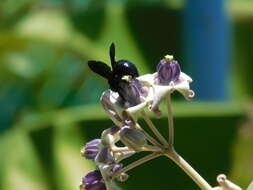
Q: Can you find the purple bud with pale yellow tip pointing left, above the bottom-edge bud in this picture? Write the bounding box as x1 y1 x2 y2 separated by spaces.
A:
81 139 101 160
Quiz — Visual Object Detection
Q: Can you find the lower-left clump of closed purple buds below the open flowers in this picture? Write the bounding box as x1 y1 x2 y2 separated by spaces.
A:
80 121 147 190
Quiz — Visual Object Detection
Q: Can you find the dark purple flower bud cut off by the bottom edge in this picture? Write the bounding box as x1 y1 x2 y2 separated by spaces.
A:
82 170 106 190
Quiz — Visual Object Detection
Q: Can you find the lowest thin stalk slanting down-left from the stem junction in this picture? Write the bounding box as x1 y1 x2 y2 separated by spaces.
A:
113 152 161 178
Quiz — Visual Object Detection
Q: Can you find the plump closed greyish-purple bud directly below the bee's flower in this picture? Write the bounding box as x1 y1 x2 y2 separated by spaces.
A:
120 126 147 151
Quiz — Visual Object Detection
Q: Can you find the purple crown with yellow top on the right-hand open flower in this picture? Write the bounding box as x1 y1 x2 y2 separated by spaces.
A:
157 58 181 85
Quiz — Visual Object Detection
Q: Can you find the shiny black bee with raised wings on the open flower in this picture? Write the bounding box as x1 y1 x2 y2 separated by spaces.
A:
88 43 139 100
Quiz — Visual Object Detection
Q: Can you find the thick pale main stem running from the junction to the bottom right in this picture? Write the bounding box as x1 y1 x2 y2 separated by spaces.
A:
164 149 212 190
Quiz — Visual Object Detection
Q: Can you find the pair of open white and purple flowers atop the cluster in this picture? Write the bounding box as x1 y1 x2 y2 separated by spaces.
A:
101 55 194 121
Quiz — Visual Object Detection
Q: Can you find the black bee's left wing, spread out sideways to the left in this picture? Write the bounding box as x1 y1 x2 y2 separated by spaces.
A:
88 61 112 79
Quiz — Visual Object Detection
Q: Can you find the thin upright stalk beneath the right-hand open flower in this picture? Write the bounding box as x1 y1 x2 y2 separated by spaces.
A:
166 94 174 146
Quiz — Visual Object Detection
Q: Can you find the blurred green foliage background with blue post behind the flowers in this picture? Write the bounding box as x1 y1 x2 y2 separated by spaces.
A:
0 0 253 190
